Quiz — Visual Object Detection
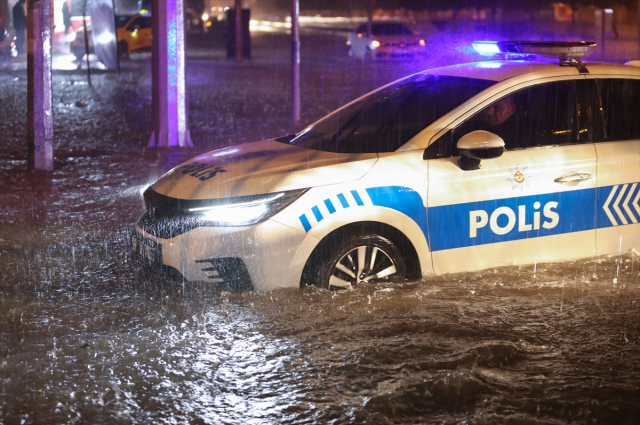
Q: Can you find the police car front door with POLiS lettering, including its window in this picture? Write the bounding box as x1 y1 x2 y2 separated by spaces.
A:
425 77 596 274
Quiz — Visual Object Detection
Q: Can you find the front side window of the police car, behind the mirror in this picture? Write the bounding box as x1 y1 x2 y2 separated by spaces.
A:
425 80 594 159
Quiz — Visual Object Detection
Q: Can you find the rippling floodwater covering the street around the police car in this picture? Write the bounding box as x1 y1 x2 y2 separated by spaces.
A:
0 27 640 424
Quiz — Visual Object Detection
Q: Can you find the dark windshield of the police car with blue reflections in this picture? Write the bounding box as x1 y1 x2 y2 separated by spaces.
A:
281 74 495 153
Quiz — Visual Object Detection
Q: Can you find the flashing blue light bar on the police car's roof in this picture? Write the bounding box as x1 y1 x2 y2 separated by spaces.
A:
473 41 597 59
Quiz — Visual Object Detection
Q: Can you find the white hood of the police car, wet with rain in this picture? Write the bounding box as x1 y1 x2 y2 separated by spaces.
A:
151 140 378 199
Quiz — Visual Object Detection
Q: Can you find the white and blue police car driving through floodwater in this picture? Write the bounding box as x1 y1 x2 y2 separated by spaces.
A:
132 42 640 290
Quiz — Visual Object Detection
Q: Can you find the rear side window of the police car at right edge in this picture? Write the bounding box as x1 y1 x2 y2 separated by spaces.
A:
591 78 640 142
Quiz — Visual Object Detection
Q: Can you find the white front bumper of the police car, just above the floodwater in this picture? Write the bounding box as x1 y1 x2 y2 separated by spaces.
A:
130 213 308 290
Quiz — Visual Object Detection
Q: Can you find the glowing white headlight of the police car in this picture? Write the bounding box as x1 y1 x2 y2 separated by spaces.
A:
187 189 307 226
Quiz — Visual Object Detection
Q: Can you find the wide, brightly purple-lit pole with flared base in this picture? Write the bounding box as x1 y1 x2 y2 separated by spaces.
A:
149 0 193 147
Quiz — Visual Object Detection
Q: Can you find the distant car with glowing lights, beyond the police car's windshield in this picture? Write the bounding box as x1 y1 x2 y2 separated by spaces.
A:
347 22 426 59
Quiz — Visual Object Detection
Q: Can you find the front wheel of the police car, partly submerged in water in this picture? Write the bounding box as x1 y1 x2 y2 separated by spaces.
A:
312 235 407 290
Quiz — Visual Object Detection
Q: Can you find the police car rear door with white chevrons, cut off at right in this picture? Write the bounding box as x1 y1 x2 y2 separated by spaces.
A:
587 75 640 255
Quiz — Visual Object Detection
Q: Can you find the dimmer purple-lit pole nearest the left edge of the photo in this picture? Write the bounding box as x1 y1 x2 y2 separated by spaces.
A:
27 0 53 171
